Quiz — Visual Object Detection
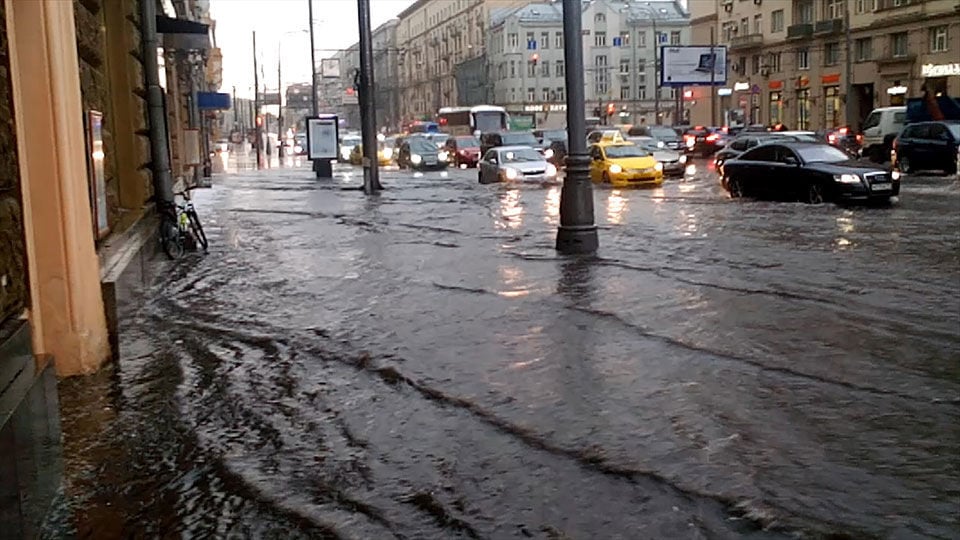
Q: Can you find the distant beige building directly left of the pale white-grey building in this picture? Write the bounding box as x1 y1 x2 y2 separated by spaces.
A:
396 0 526 122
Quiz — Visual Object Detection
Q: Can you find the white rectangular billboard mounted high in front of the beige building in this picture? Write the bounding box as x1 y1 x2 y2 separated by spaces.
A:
660 45 727 86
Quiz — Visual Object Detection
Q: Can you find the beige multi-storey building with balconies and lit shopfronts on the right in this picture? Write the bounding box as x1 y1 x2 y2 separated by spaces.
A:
688 0 960 130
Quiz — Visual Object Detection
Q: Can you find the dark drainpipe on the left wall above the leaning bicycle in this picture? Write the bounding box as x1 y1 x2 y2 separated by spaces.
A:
140 2 173 202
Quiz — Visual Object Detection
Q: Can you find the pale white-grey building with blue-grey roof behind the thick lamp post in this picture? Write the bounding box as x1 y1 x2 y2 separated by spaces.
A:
488 0 690 126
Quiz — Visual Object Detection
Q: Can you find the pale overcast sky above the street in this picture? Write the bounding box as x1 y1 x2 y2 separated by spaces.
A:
210 0 412 97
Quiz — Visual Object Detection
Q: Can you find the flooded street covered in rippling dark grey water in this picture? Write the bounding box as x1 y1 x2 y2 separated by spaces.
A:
59 163 960 539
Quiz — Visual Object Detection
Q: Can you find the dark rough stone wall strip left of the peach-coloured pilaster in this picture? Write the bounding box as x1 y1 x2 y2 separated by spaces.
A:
0 0 29 330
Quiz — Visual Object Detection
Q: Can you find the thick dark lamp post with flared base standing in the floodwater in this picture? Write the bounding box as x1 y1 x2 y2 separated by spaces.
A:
557 0 599 254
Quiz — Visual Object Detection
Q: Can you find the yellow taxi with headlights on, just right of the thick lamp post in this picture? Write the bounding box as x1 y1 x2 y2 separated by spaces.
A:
590 142 663 187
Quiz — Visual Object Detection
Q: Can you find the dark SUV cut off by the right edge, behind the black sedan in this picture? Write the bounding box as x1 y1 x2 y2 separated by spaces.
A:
890 120 960 174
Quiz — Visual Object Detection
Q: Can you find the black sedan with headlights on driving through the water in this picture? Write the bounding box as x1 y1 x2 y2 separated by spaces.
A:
720 141 900 204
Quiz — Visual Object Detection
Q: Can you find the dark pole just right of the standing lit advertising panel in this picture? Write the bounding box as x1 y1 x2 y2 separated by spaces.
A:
357 0 383 195
